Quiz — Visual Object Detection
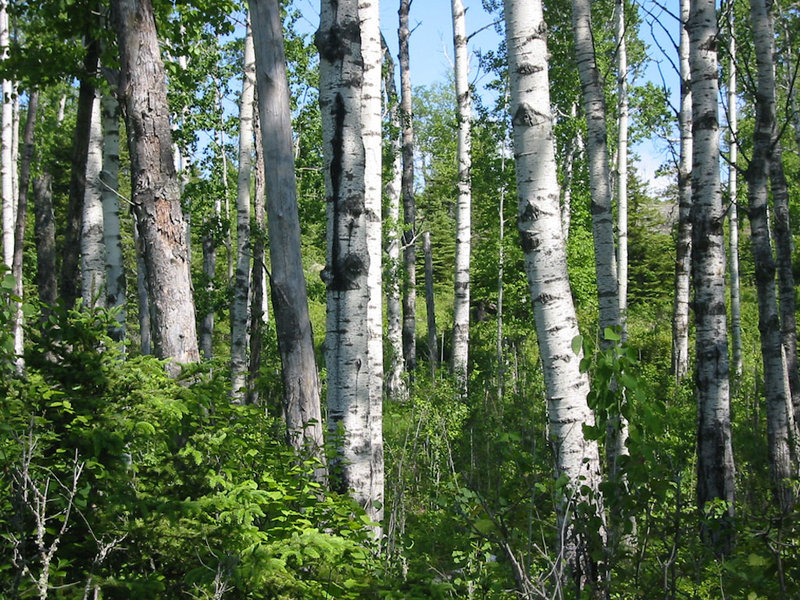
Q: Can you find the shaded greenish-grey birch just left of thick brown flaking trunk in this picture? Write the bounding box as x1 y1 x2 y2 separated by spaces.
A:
100 94 127 342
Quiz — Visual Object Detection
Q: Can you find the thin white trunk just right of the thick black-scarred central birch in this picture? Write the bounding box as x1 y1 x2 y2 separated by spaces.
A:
383 43 408 402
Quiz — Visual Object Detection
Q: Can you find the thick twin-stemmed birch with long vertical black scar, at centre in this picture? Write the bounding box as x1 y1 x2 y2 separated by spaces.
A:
315 0 383 535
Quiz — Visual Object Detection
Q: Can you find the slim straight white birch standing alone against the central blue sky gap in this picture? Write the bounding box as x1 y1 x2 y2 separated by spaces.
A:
451 0 472 398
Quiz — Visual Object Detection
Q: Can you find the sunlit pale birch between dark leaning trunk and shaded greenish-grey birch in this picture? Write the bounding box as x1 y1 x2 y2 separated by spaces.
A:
81 91 106 308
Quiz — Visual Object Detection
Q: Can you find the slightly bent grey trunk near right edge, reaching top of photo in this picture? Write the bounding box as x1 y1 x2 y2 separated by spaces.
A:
747 0 795 510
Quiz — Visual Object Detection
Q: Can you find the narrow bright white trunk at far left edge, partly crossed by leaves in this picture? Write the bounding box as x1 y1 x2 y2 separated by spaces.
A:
0 1 12 269
